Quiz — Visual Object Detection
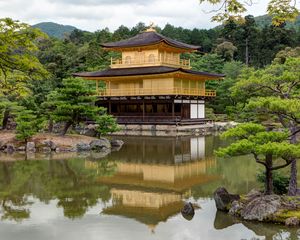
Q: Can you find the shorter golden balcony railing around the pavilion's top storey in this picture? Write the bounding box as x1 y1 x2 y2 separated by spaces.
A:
110 58 191 69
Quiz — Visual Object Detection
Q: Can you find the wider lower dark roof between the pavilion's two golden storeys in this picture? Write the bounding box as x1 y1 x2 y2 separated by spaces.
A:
73 66 225 79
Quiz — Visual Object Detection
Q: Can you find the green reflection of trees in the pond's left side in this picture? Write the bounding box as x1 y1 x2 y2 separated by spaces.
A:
0 159 114 221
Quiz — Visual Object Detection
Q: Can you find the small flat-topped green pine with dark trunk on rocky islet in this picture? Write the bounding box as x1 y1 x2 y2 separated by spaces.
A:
217 123 300 194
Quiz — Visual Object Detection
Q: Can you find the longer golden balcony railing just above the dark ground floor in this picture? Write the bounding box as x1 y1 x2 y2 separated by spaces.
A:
99 88 216 97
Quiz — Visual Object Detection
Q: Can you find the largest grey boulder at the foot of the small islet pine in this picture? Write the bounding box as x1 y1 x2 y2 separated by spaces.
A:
241 195 281 221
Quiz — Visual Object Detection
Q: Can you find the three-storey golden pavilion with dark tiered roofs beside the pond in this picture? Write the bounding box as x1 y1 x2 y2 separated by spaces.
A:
74 27 224 124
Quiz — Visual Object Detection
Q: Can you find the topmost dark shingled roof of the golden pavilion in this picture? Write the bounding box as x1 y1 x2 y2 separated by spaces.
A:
101 31 200 51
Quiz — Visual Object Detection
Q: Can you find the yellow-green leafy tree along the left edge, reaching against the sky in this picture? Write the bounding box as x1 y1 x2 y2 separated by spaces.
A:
0 18 47 129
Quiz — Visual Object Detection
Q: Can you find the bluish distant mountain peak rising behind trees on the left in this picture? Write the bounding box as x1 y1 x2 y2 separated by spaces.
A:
32 22 77 39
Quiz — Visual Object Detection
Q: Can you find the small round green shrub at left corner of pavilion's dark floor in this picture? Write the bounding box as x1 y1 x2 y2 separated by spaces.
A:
96 114 120 136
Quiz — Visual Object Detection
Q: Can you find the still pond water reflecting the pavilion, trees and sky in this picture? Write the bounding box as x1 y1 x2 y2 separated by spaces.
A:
0 136 300 240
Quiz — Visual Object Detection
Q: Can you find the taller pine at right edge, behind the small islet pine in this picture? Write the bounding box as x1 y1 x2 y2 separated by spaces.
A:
232 58 300 195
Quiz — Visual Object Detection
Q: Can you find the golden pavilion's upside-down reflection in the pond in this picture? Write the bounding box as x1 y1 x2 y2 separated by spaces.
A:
86 137 217 229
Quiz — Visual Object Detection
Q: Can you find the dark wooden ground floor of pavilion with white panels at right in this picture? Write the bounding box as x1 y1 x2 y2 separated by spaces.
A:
97 99 207 125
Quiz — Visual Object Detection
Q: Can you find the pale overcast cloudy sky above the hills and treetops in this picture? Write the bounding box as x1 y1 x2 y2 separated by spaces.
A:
0 0 268 31
